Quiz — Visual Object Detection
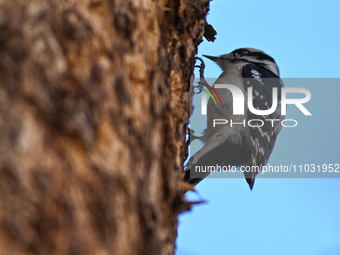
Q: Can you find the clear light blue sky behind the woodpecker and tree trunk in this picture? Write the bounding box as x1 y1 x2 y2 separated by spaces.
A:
176 0 340 255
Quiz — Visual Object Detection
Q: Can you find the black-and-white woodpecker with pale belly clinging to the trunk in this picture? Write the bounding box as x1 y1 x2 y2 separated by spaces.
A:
184 48 284 189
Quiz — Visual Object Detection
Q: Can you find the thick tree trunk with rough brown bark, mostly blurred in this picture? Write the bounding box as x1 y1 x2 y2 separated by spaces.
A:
0 0 212 255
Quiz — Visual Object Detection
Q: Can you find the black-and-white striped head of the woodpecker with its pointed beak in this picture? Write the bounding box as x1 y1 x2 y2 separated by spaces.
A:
203 48 279 76
